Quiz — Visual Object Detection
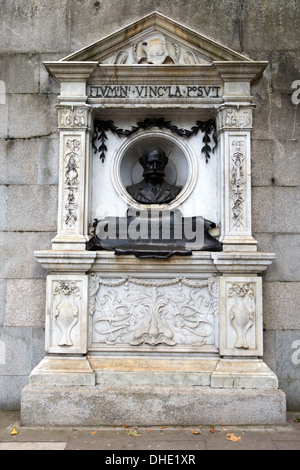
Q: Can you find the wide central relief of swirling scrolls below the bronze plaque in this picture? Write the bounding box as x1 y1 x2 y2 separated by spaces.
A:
90 275 219 346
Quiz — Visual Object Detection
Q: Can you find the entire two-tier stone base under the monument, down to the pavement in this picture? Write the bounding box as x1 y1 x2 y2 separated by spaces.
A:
21 355 286 426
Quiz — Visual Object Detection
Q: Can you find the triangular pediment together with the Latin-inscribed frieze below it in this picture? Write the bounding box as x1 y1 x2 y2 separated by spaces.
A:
44 12 267 108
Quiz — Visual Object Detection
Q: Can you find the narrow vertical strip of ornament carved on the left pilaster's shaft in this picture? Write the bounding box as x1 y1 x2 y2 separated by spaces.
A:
64 139 80 228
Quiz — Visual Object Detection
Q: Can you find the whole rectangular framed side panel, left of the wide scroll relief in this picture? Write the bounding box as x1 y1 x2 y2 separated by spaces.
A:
46 275 87 354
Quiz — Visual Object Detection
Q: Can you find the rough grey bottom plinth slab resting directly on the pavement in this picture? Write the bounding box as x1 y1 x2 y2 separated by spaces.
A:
21 385 286 426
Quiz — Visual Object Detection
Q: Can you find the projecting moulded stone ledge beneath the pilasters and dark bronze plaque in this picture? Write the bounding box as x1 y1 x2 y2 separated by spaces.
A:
34 250 275 276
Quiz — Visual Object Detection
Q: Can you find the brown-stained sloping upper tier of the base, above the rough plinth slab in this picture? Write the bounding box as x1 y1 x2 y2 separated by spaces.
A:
29 356 278 390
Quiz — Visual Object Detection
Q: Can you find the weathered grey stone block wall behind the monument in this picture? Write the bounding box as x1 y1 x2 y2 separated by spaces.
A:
0 0 300 410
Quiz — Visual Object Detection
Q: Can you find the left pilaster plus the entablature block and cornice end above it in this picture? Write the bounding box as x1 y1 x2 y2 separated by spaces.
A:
45 62 97 250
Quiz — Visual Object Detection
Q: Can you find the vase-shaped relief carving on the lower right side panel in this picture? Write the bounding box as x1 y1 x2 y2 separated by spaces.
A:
228 283 255 349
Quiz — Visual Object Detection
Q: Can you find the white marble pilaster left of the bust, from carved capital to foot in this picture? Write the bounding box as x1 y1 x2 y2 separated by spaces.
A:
52 104 91 250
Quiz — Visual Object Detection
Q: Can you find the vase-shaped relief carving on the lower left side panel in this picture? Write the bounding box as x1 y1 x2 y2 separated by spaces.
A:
54 281 81 346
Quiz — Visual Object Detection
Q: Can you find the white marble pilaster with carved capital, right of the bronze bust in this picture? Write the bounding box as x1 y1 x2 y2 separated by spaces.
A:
217 103 256 251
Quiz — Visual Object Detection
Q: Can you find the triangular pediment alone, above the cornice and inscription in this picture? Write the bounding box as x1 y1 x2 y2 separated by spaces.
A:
62 12 251 65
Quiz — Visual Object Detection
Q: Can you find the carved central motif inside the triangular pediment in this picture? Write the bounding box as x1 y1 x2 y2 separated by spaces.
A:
136 33 174 65
